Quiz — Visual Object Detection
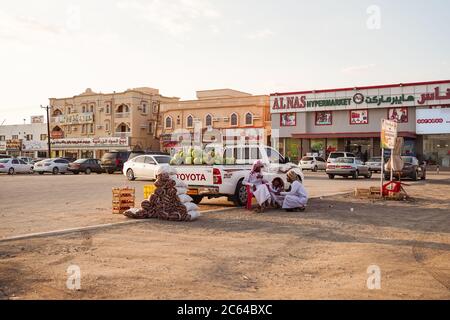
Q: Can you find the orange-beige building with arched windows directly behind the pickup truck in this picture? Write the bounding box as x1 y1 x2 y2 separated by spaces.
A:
158 89 271 151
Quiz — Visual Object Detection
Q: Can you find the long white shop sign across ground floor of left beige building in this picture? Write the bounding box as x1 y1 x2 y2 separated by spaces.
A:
50 137 129 149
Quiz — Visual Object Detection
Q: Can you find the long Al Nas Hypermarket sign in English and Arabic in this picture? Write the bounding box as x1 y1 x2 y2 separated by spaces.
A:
270 83 450 113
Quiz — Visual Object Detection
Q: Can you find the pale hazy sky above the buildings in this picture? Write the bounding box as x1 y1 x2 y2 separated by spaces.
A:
0 0 450 125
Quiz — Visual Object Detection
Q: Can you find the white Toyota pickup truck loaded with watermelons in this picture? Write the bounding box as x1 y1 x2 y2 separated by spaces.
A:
173 145 303 206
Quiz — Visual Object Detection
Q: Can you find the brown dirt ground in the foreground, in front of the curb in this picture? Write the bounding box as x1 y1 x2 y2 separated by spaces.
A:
0 179 450 299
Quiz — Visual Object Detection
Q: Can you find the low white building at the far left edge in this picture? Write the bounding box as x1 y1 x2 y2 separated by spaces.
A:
0 123 48 158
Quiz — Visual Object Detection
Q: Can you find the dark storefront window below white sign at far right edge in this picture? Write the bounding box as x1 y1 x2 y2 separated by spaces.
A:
423 134 450 167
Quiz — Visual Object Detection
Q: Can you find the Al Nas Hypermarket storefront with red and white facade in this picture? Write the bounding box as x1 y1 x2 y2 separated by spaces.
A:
270 80 450 161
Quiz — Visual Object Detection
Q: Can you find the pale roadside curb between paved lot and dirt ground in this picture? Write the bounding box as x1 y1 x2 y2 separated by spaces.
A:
0 191 352 244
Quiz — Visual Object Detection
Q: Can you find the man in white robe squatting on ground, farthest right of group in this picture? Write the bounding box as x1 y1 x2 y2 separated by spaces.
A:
280 170 308 212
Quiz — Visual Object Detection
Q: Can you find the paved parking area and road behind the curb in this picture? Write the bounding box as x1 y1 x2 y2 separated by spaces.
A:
0 172 448 238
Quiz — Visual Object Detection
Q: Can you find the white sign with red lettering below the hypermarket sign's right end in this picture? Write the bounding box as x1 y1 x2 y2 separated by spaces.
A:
416 108 450 134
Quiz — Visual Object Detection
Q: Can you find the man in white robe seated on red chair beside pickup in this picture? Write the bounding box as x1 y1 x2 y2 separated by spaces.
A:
243 160 271 212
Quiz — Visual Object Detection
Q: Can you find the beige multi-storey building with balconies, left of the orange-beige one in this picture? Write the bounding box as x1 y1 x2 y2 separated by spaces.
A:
49 87 179 158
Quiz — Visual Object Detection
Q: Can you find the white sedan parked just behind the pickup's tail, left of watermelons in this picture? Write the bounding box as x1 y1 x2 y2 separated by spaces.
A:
123 155 171 181
